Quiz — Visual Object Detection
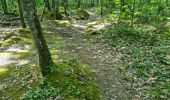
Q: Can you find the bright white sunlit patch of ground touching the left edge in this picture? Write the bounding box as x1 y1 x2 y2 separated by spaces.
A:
0 52 14 66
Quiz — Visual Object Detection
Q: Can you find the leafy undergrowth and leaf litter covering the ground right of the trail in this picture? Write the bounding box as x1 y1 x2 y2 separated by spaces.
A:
94 24 170 100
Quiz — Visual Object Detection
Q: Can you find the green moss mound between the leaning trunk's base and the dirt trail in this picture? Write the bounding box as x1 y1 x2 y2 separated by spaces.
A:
44 59 100 100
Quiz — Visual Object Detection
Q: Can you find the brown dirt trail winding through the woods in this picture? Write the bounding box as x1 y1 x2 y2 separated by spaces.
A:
43 11 136 100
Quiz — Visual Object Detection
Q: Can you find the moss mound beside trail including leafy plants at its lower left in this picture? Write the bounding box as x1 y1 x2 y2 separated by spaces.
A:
21 58 100 100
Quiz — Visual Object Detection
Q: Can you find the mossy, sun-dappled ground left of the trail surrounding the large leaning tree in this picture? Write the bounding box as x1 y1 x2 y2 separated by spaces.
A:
0 29 100 100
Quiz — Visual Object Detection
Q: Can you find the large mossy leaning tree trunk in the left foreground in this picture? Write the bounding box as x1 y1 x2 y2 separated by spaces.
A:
22 0 54 76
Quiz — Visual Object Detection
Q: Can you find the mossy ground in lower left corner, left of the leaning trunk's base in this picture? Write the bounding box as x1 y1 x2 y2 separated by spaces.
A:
0 62 41 100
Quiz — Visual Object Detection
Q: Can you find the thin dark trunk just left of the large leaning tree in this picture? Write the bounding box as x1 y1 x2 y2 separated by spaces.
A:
18 0 26 28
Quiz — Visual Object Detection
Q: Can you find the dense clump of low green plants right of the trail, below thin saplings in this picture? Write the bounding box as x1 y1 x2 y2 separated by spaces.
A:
106 24 158 46
